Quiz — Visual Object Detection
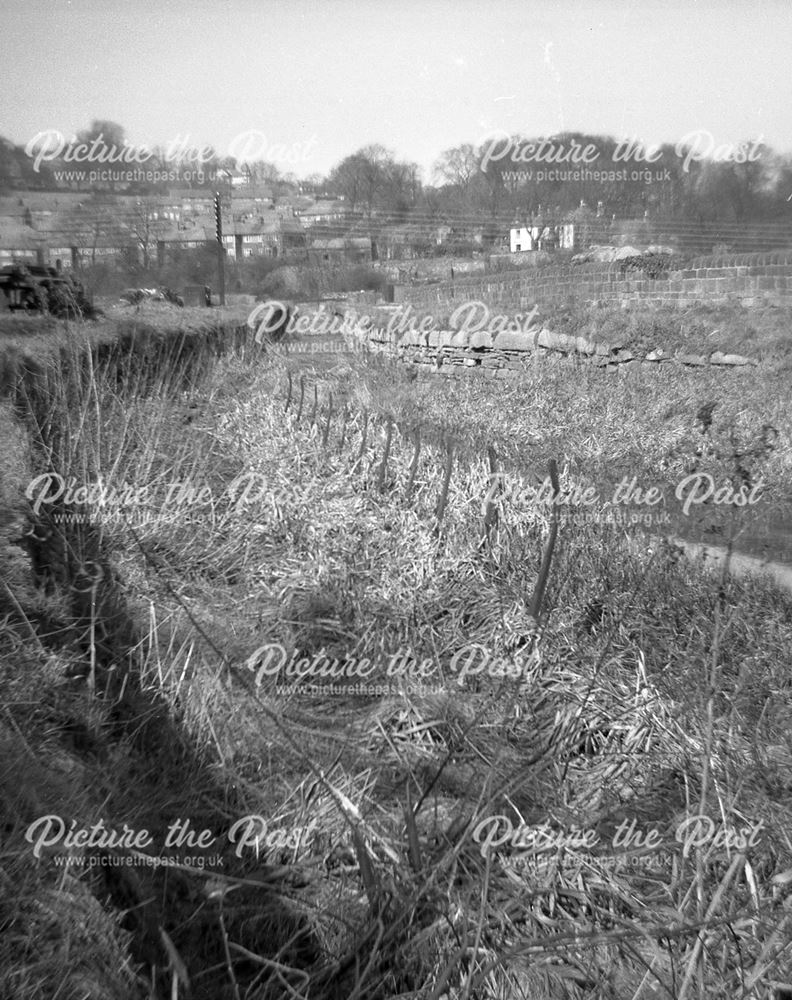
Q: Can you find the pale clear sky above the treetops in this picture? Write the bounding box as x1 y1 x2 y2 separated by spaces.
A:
0 0 792 180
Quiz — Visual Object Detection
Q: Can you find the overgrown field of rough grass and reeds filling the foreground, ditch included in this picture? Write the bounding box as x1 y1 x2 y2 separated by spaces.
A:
0 314 792 1000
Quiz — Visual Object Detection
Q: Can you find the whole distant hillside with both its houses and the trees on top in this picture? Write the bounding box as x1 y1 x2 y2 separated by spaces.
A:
0 121 792 293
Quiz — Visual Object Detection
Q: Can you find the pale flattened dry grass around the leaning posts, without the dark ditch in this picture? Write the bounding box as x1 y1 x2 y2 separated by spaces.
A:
0 310 792 1000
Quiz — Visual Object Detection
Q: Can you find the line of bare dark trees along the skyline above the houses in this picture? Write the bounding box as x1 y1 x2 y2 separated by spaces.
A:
0 120 792 230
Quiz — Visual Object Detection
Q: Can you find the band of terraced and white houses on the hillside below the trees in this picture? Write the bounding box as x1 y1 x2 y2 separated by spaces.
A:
0 187 724 282
